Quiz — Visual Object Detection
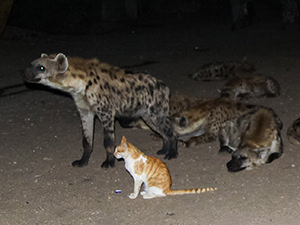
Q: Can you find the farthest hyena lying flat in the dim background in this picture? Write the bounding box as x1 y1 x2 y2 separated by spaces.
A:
189 58 255 81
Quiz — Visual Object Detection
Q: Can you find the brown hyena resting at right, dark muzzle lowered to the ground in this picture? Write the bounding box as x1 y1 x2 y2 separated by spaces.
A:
219 108 283 172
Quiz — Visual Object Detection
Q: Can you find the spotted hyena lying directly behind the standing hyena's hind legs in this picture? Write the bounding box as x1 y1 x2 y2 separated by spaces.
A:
171 98 274 147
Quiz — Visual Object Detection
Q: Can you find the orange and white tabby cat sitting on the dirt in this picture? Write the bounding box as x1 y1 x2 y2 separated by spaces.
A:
114 136 216 199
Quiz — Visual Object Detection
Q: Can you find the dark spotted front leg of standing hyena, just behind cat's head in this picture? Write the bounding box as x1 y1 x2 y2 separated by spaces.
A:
98 112 115 168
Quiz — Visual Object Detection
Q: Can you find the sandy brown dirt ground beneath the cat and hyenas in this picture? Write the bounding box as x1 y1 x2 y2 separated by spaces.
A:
0 18 300 225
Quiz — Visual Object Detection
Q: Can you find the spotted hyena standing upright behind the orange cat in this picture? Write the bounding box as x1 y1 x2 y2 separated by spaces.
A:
25 53 177 167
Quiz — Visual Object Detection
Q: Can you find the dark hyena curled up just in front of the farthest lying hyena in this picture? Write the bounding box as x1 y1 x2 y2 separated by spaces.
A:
219 74 280 101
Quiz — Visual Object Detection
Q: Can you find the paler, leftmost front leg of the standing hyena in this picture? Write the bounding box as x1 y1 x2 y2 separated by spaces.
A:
72 109 95 167
